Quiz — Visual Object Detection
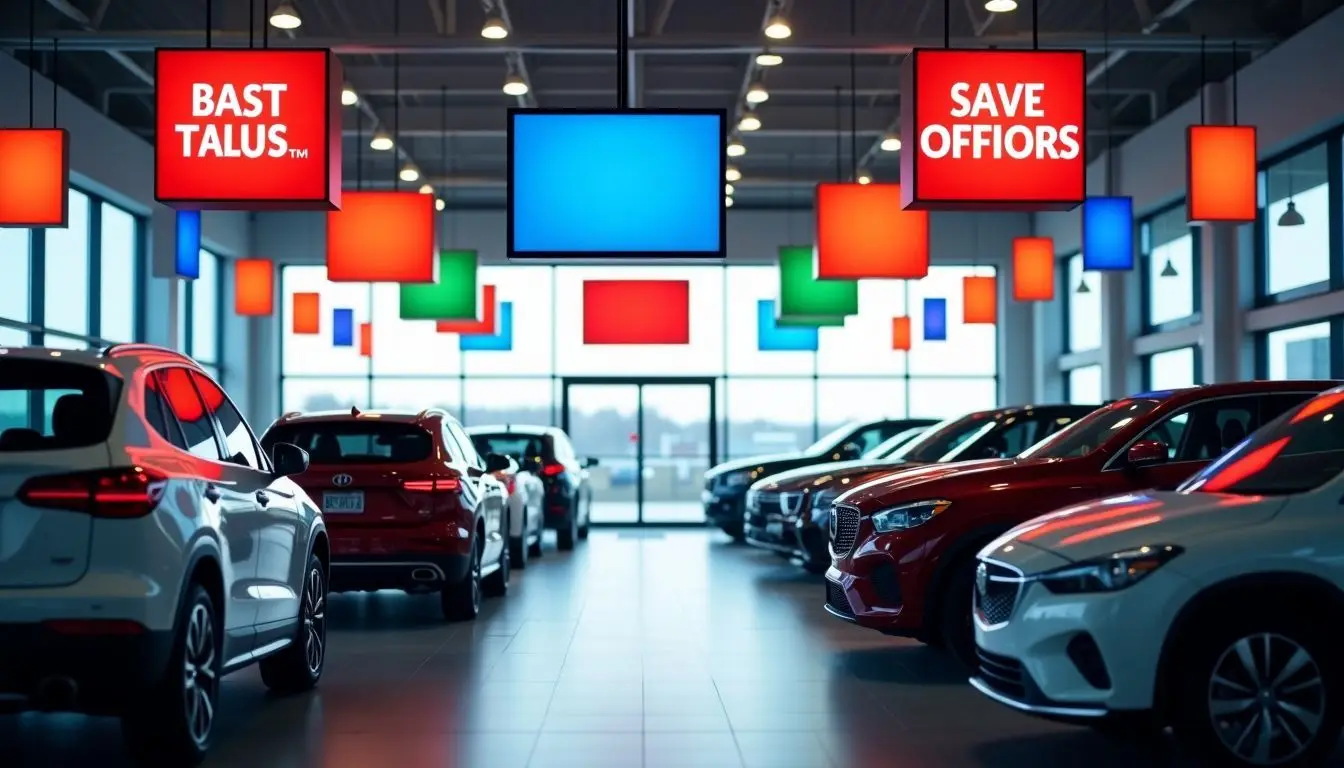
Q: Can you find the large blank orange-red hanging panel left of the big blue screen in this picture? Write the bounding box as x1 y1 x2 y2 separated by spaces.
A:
327 192 434 282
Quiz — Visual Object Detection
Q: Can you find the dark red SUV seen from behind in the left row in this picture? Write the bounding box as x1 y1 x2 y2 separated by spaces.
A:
262 408 511 620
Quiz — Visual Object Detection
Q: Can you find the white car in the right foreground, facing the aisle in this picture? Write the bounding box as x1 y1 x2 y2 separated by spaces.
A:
972 387 1344 765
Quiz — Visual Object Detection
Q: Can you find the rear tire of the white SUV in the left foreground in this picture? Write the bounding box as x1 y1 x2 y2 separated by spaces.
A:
121 582 223 765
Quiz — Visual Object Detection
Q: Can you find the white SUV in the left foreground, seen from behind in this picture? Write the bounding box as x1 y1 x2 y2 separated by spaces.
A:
0 344 329 765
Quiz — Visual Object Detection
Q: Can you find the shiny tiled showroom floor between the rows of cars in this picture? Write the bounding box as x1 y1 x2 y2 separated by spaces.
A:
0 529 1306 768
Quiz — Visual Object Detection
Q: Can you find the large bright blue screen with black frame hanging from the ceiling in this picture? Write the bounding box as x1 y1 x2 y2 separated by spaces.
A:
508 109 727 260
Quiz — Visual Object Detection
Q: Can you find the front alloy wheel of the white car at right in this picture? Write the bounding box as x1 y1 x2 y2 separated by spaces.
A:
1208 632 1325 765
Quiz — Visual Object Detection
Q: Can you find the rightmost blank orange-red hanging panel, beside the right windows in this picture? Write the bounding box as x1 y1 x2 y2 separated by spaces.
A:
1185 125 1257 223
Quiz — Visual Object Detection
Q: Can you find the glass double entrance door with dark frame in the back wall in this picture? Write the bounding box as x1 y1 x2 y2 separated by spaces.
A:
562 378 718 525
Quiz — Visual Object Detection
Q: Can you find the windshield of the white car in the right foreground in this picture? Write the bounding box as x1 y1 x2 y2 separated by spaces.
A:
1177 390 1344 496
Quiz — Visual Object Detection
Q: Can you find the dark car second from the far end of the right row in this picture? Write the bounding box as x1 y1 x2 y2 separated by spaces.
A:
746 405 1097 573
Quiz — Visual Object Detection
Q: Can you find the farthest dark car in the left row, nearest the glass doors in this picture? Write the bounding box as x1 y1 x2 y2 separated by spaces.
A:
472 424 597 551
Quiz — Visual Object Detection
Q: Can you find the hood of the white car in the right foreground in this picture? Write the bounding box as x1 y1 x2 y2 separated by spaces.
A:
982 491 1286 562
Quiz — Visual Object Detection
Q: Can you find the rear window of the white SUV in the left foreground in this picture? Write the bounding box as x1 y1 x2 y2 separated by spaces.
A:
0 358 121 453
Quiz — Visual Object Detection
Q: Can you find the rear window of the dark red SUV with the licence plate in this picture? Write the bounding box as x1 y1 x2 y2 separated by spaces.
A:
261 421 434 464
